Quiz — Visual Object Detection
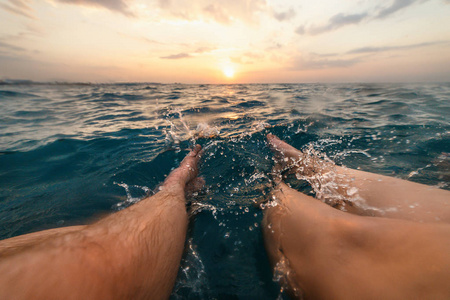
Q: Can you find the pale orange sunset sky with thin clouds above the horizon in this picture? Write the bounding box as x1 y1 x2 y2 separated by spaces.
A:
0 0 450 83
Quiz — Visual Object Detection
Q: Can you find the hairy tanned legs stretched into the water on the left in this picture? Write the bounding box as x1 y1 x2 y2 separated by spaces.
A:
0 146 201 299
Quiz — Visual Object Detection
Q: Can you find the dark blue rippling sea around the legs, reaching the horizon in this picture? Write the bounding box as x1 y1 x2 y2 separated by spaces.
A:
0 83 450 299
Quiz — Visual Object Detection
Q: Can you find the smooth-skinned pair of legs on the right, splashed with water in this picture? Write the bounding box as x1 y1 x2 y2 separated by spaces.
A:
263 135 450 299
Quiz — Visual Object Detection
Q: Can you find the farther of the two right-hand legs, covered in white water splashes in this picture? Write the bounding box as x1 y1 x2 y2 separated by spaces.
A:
268 134 450 223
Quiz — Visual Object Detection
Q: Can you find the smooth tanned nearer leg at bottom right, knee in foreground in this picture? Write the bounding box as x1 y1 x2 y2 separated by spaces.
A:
263 183 450 299
